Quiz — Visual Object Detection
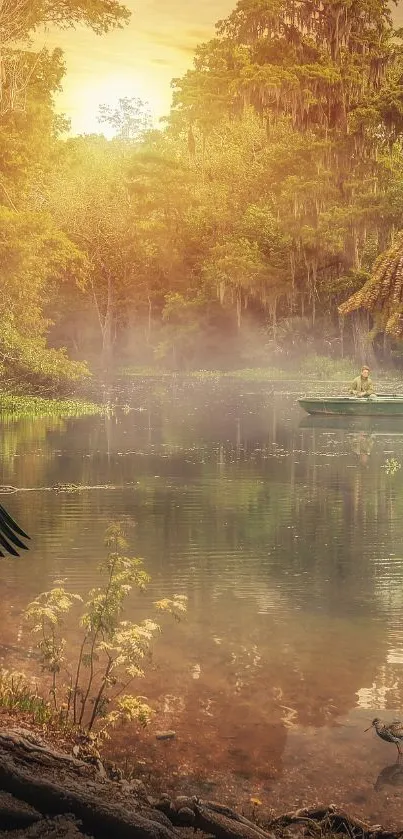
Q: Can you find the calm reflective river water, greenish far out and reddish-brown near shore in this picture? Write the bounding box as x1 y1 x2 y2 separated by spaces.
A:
0 381 403 826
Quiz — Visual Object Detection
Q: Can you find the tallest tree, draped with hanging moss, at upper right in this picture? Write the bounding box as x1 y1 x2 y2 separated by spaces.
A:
166 0 403 352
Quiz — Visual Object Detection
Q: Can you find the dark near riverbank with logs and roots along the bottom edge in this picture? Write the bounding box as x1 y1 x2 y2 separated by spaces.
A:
0 711 401 839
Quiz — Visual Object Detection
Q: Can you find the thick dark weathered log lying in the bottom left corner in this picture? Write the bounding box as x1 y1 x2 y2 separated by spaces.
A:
0 730 176 839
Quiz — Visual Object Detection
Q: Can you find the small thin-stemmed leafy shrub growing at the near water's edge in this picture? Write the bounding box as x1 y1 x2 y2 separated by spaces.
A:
25 524 187 736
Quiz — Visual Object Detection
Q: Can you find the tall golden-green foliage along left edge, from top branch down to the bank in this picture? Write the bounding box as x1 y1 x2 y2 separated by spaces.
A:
0 0 130 392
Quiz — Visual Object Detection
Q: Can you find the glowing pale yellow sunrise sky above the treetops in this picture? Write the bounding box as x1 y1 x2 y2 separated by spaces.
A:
41 0 236 134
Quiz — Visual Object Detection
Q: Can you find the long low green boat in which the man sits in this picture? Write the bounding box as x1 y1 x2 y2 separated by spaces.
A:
298 395 403 417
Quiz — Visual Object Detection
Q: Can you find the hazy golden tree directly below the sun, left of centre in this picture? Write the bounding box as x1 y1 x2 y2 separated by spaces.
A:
47 130 205 367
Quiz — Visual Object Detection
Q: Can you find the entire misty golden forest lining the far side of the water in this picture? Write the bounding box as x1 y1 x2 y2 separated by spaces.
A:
0 0 403 390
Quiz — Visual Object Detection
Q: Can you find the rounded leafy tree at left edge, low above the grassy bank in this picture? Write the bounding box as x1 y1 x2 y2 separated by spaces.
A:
0 207 88 392
